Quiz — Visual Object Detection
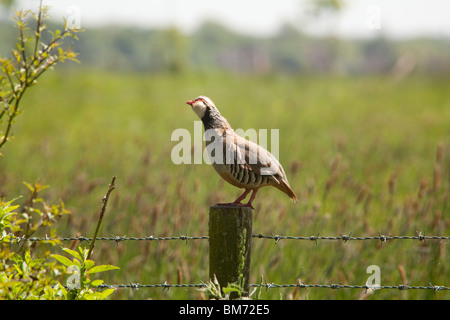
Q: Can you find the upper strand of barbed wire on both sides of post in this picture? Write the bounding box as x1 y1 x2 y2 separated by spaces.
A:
10 232 450 244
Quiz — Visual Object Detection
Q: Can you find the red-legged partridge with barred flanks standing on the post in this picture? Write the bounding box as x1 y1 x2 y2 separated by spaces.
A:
186 96 298 208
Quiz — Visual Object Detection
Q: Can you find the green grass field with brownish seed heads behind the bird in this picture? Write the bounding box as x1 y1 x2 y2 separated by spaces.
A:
0 69 450 299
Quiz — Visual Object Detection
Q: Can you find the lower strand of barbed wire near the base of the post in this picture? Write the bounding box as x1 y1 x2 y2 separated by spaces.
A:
93 281 450 292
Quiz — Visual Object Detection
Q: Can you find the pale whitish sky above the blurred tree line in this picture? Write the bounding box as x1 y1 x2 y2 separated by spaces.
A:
13 0 450 38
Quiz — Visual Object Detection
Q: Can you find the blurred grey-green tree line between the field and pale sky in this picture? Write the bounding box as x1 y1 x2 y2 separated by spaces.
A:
0 19 450 77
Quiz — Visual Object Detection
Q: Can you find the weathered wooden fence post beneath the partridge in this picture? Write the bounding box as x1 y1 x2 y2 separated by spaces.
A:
209 206 253 298
